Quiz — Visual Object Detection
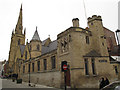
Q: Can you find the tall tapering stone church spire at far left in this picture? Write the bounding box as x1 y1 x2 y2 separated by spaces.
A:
15 4 23 34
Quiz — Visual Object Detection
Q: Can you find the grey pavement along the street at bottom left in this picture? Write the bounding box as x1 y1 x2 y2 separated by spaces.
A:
0 79 62 90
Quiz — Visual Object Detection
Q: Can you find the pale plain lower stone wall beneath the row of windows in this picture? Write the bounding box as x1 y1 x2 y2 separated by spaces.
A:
21 71 61 88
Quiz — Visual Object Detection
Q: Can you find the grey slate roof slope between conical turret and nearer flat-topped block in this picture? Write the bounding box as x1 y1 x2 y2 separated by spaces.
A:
42 40 57 55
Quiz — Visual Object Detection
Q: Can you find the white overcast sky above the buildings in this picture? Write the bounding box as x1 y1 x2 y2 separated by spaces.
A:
0 0 119 60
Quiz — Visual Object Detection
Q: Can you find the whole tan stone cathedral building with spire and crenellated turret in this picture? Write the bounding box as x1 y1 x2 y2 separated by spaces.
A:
8 5 119 88
